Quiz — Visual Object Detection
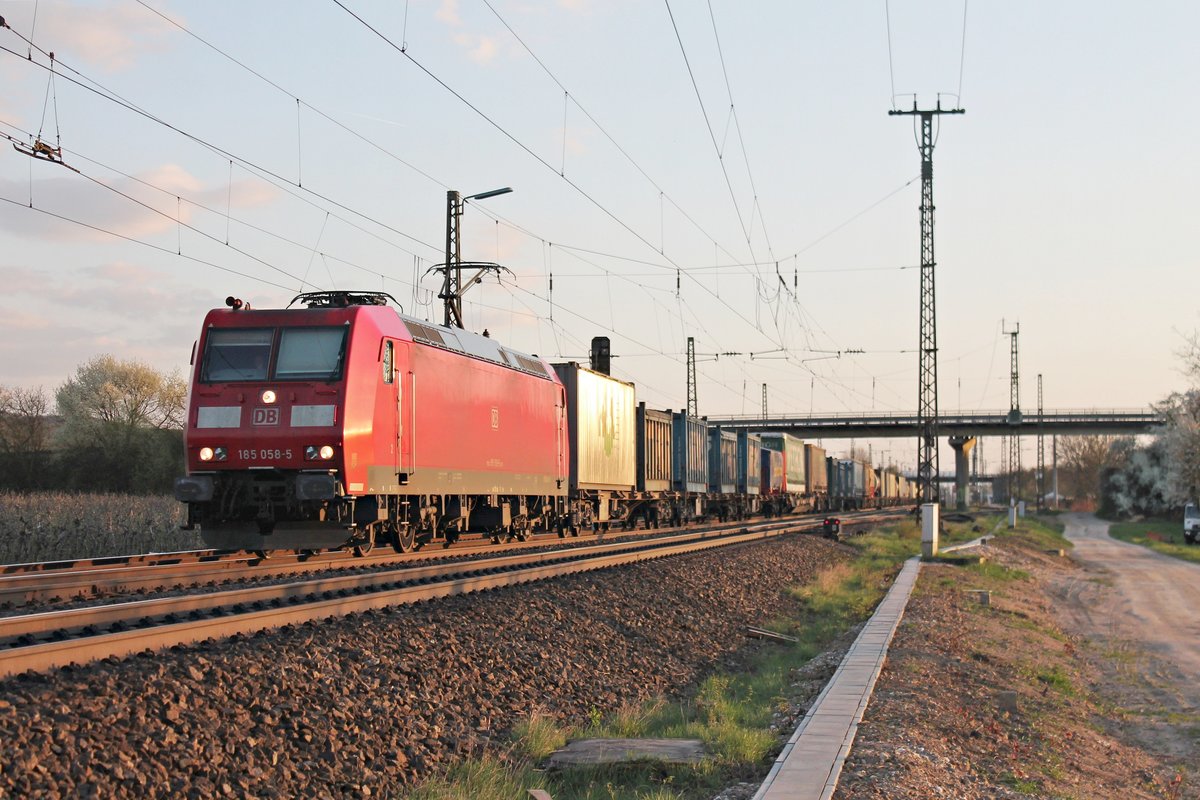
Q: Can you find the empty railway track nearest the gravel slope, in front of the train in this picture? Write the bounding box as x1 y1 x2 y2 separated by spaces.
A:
0 521 830 678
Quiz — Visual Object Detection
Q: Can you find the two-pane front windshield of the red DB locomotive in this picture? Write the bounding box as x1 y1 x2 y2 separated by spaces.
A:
200 326 346 384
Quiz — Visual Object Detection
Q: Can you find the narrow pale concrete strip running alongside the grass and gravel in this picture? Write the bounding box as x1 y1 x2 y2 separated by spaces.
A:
754 558 920 800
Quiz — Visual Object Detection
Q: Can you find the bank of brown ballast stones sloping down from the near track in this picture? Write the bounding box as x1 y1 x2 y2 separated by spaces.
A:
0 536 845 798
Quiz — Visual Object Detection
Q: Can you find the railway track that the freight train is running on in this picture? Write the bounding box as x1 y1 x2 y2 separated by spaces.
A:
0 511 894 607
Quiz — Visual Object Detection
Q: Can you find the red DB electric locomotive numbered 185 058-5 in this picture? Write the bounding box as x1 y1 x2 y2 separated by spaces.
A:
175 291 569 552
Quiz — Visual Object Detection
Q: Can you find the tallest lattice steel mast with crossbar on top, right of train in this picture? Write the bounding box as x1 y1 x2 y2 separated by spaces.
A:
888 98 964 503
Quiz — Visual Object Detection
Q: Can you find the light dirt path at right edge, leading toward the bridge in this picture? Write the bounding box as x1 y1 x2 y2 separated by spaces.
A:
1050 515 1200 763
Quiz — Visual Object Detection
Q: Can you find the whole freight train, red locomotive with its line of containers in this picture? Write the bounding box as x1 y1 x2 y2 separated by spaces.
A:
175 291 914 552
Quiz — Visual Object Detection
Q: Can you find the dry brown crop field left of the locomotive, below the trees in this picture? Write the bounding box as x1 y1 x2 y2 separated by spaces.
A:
0 492 202 564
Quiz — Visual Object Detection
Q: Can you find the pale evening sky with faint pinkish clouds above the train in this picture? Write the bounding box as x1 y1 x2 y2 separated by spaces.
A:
0 0 1200 465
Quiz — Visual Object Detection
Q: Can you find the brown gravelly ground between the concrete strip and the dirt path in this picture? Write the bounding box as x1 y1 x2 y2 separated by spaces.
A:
834 517 1200 800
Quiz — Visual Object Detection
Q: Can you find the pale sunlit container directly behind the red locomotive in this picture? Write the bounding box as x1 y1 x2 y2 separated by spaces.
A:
553 361 637 492
